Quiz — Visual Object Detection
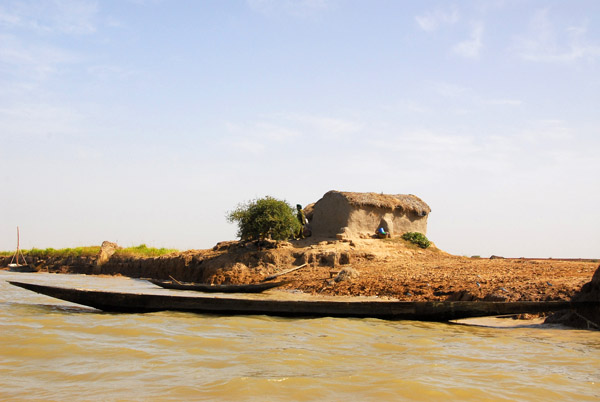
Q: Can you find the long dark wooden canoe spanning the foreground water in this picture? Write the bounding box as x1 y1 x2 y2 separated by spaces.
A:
9 281 584 321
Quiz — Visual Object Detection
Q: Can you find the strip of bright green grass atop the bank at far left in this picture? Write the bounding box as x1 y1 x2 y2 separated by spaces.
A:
0 244 179 259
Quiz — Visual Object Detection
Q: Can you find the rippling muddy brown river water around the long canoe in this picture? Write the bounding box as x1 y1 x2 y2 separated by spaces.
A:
0 271 600 401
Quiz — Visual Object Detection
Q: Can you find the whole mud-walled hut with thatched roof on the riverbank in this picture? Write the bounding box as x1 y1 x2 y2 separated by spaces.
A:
310 191 431 238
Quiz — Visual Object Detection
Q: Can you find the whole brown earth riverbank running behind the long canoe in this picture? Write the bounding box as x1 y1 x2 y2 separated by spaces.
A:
0 238 598 301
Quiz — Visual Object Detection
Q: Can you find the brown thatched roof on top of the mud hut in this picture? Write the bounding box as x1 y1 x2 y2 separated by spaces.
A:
326 191 431 216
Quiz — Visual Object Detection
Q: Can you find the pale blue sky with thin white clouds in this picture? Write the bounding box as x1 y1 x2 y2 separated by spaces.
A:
0 0 600 258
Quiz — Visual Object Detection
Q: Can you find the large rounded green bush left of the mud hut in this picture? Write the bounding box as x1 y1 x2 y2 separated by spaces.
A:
227 196 300 240
